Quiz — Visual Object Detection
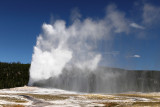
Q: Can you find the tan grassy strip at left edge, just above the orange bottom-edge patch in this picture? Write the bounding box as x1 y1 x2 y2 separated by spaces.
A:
0 96 28 103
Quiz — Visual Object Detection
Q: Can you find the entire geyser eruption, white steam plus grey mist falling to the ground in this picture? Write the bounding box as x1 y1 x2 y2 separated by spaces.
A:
29 5 159 92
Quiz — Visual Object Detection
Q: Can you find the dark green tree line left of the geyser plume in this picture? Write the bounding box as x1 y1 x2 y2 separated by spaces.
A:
0 62 30 89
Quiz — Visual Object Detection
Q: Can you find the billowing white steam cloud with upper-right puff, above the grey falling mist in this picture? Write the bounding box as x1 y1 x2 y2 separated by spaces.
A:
29 5 128 84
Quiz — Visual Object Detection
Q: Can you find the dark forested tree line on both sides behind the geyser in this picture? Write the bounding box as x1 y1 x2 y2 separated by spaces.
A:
0 62 160 92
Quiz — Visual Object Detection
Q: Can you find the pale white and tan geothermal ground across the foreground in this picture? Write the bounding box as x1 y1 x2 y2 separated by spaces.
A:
0 86 160 107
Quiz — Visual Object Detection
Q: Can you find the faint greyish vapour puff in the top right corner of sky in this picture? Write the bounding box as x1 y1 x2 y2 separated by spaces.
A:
143 4 160 24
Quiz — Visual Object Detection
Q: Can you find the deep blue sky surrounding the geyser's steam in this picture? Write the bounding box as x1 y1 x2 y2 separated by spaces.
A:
0 0 160 70
